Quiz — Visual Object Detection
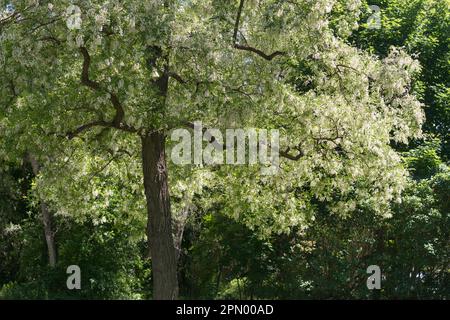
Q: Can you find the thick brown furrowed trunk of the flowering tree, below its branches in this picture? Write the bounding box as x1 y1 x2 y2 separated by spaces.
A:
142 133 178 300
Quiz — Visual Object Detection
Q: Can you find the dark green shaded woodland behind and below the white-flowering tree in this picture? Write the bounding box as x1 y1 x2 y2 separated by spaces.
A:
0 0 450 299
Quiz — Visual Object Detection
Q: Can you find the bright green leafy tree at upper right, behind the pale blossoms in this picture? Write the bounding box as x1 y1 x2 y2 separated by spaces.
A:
351 0 450 161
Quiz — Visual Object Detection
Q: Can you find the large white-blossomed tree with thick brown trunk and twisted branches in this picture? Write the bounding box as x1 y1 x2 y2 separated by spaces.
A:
0 0 423 299
